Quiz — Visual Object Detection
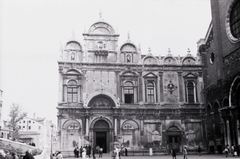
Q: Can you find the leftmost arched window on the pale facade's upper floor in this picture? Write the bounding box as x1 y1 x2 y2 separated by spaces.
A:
67 80 77 103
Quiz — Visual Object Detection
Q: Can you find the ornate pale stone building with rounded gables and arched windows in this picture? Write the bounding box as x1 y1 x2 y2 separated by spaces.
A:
57 16 206 152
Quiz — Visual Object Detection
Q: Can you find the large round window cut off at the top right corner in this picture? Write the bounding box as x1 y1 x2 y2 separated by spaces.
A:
230 0 240 38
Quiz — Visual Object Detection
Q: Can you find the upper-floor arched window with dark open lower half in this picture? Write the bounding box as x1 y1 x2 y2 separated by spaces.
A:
124 82 134 103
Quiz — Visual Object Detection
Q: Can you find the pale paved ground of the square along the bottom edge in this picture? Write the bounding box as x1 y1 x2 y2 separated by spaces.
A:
64 154 240 159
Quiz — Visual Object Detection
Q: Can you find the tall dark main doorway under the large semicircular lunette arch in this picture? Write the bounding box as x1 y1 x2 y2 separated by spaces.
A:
93 119 111 153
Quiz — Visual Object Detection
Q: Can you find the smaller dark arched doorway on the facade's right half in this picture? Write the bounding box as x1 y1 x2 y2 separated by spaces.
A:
167 125 182 152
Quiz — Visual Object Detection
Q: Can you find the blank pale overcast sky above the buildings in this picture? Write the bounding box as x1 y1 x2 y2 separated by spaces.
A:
0 0 211 123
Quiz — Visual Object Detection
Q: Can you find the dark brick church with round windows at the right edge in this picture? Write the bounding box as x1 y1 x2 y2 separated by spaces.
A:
198 0 240 153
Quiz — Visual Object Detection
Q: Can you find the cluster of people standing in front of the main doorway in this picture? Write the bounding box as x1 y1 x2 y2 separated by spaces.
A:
73 145 103 159
